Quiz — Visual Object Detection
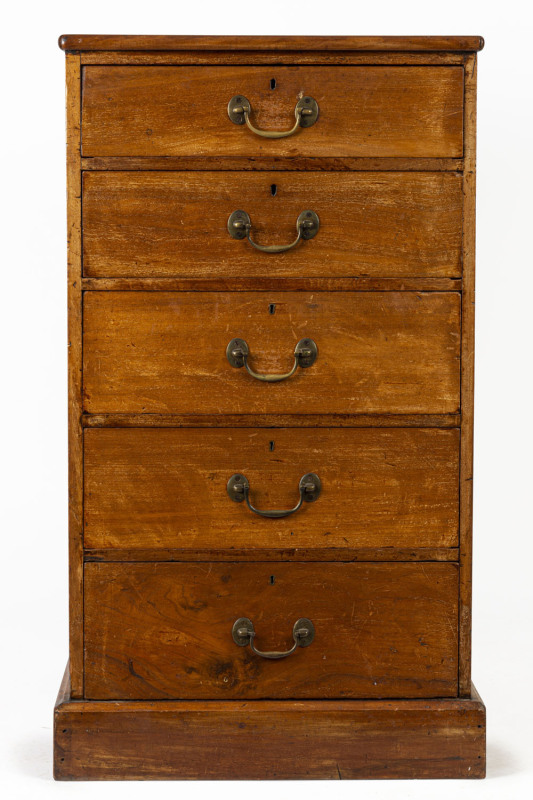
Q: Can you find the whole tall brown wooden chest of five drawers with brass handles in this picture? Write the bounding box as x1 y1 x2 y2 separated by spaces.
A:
55 36 485 780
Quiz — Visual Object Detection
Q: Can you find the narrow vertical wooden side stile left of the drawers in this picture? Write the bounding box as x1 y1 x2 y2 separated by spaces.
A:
66 55 83 697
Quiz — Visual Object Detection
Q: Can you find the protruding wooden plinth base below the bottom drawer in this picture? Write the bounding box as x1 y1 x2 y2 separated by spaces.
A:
54 664 486 780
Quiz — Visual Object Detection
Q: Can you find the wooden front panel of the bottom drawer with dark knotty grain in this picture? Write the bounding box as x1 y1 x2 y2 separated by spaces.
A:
85 562 458 700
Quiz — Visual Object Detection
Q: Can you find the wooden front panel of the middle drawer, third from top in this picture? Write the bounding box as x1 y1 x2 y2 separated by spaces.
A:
83 292 460 414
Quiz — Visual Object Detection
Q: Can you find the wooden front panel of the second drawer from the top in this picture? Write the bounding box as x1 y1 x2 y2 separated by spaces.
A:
83 171 463 278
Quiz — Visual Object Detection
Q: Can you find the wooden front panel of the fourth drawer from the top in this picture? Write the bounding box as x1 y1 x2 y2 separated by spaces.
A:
84 428 459 552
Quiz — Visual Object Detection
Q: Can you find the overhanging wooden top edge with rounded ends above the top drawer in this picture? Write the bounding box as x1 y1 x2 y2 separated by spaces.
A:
59 34 484 52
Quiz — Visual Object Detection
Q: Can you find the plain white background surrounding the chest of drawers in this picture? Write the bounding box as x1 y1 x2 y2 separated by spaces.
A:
0 0 533 800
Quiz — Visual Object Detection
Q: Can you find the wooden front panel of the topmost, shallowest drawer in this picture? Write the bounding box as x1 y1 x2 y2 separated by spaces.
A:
82 66 464 158
